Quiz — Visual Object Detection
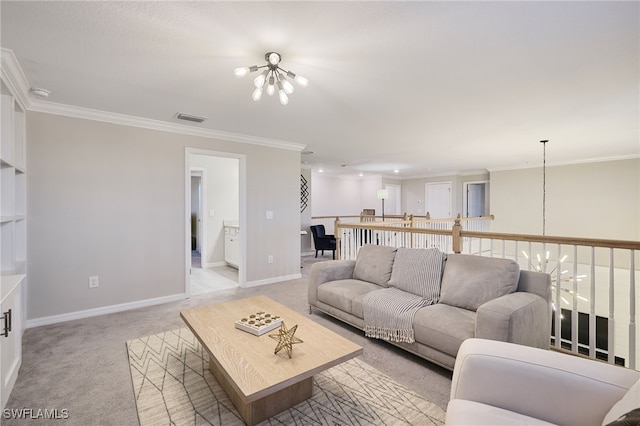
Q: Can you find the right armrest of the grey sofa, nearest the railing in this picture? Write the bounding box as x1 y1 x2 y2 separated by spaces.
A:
475 292 551 349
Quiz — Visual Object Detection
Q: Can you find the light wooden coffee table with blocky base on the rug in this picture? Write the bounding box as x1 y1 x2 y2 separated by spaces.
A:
180 296 362 425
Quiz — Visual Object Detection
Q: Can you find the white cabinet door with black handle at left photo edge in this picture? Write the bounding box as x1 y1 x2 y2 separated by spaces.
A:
0 285 22 408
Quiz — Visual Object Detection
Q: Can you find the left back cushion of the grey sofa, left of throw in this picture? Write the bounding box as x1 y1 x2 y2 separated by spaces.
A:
353 244 396 287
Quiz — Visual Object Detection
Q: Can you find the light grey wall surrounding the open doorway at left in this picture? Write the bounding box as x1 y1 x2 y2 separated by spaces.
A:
27 112 300 319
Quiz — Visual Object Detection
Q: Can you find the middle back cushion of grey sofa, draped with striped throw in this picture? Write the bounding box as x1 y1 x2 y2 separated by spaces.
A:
389 248 446 303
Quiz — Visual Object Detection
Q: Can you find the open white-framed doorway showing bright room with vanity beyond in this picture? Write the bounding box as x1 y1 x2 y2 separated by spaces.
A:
185 148 246 297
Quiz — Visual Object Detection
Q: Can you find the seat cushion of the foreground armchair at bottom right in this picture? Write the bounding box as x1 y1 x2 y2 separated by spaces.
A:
445 399 552 426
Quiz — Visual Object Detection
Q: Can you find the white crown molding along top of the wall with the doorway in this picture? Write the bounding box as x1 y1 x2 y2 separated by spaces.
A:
0 48 306 152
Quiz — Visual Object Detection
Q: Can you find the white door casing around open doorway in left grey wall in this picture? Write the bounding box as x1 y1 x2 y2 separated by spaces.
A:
184 147 247 298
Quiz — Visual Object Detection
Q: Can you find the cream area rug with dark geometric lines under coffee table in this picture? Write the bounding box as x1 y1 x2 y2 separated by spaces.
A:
127 328 445 426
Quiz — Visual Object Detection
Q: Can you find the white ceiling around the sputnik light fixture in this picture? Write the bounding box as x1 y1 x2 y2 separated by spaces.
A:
0 0 640 177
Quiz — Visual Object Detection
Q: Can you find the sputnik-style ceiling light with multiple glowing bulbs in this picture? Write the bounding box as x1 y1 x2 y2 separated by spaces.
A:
234 52 309 105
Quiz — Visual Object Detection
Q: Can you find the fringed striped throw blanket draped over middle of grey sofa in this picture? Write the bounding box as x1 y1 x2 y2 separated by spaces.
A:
362 248 446 343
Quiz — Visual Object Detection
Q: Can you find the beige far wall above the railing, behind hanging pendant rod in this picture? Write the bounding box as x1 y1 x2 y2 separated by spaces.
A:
490 159 640 241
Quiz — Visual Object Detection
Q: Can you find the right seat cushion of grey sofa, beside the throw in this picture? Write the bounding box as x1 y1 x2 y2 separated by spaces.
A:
413 303 476 357
